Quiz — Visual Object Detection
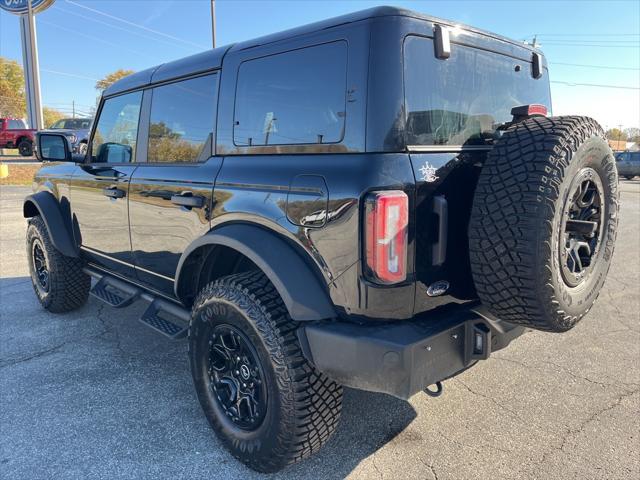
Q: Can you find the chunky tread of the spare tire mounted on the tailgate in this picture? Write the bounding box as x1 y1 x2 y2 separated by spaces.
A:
469 116 616 331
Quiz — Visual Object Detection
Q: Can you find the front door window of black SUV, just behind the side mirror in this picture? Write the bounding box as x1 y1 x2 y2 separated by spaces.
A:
91 92 142 163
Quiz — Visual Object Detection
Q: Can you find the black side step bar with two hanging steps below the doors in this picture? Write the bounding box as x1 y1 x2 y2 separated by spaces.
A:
83 267 191 340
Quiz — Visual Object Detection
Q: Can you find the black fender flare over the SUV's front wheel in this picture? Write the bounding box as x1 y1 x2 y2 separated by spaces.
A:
22 191 78 258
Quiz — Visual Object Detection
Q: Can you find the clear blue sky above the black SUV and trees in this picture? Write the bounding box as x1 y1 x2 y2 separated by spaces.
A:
0 0 640 128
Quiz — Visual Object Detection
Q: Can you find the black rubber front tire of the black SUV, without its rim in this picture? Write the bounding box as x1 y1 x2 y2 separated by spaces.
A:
27 216 91 313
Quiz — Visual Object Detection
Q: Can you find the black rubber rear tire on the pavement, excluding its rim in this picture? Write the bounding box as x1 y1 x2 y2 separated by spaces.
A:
189 271 342 472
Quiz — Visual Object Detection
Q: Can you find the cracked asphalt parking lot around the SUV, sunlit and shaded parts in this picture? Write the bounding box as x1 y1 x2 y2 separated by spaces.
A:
0 181 640 480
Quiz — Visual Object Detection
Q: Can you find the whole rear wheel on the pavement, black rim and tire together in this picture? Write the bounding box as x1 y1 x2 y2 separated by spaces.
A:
189 271 342 472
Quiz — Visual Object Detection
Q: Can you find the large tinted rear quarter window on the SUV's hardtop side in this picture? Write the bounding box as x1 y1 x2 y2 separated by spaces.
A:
233 42 347 146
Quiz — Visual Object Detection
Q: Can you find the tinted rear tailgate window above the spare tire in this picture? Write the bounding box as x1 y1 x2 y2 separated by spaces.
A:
404 36 551 145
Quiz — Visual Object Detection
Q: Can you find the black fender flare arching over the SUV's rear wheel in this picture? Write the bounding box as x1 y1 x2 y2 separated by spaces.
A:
174 224 336 321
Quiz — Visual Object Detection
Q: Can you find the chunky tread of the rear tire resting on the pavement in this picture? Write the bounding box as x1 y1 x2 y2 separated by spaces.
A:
189 271 342 472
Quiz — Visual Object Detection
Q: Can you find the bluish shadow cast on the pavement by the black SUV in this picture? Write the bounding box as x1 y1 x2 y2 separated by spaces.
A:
0 276 417 480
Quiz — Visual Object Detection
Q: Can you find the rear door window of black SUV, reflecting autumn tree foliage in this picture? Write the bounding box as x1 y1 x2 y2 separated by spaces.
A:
147 75 218 162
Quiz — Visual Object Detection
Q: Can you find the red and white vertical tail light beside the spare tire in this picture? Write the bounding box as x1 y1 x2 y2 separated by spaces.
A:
365 190 409 284
